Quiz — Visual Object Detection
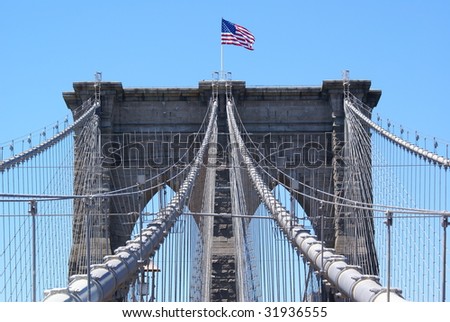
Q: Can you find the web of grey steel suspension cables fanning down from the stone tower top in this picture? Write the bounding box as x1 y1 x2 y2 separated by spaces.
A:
0 82 450 301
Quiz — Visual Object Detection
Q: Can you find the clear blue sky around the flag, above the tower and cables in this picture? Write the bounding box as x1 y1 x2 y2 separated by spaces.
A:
0 0 450 144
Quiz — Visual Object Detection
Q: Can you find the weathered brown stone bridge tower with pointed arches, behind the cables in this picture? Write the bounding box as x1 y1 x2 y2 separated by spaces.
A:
63 80 381 301
